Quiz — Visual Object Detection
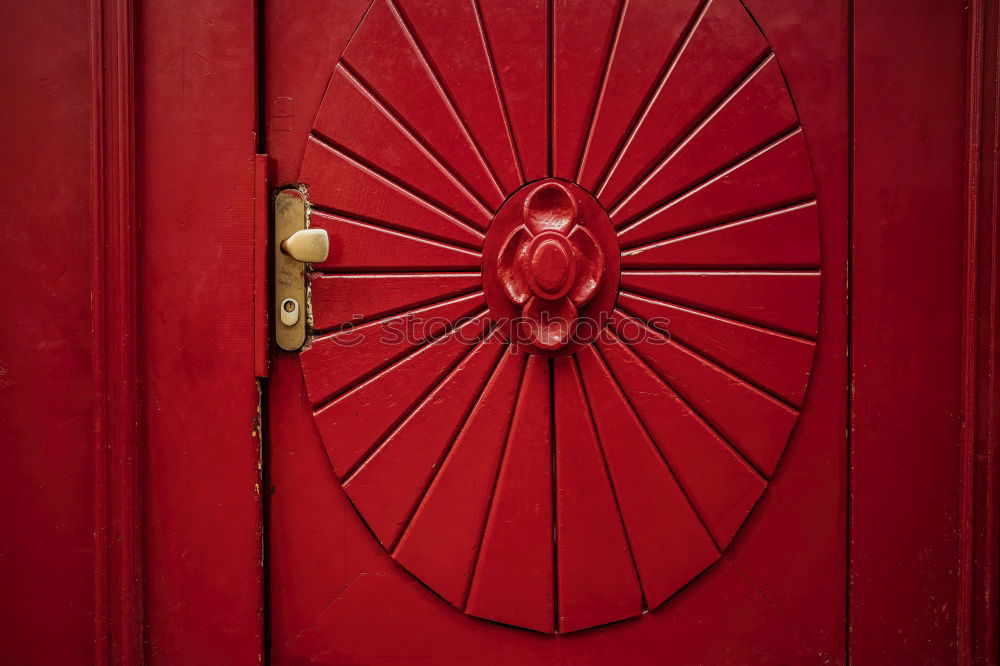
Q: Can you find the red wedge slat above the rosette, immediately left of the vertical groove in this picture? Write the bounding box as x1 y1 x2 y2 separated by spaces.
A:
476 0 551 181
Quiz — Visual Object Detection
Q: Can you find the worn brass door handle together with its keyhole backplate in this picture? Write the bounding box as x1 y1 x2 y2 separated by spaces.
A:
273 190 330 351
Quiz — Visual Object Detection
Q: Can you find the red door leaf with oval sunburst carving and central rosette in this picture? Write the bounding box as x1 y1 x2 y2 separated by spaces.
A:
265 0 848 664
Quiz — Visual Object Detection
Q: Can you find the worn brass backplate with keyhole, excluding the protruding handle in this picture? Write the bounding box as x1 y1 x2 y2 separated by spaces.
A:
273 189 308 351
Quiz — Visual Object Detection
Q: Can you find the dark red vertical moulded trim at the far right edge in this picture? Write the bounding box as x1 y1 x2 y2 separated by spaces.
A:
956 0 1000 664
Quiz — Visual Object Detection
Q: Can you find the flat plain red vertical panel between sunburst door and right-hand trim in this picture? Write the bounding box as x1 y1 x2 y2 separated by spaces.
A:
850 2 976 663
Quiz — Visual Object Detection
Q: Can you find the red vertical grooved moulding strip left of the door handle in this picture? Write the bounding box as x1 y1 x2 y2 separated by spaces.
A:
90 0 143 666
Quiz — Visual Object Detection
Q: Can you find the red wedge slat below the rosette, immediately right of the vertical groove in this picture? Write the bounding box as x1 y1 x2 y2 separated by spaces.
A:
552 358 642 632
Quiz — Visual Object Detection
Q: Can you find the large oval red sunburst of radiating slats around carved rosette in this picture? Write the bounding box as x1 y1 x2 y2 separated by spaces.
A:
300 0 820 633
